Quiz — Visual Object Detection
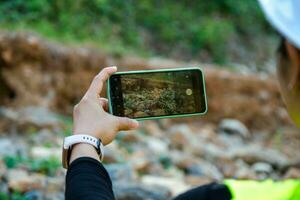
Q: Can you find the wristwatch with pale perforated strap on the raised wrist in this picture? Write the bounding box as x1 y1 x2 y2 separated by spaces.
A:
62 135 104 169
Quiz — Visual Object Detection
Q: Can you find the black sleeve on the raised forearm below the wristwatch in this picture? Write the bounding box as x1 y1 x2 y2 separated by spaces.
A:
65 157 115 200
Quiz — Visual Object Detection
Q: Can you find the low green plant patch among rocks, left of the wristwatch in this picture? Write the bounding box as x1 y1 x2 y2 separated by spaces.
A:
3 156 61 176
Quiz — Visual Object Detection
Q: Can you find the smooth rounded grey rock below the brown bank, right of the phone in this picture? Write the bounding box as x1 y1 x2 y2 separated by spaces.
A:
219 119 250 138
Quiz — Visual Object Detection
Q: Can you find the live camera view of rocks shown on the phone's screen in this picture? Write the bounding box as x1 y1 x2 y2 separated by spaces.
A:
120 70 205 118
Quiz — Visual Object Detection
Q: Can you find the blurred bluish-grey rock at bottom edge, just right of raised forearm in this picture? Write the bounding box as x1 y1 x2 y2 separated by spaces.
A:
113 182 171 200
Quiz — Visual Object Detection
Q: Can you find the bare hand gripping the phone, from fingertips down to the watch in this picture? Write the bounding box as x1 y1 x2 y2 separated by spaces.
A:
73 67 139 145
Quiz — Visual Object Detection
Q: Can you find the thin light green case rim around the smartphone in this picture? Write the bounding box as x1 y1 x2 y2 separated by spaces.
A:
106 67 208 121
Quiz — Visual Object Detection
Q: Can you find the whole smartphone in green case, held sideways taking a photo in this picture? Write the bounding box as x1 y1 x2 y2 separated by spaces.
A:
107 67 207 120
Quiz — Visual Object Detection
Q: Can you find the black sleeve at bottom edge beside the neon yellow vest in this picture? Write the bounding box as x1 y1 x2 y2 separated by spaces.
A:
174 183 232 200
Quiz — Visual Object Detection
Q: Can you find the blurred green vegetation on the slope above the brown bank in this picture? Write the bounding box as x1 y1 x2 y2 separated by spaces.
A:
0 0 271 63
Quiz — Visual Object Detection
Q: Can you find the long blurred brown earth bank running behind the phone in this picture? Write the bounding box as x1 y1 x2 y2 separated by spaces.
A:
0 33 289 130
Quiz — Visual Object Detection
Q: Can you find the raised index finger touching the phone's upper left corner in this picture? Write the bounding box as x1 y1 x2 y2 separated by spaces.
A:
86 66 117 97
